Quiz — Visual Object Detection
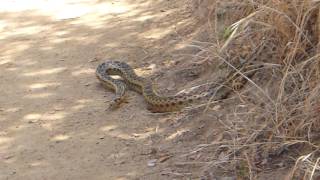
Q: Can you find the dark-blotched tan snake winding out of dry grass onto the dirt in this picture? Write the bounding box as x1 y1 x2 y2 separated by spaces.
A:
96 61 211 112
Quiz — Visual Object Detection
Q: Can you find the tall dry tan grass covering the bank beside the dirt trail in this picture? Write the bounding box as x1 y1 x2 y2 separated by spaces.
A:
188 0 320 179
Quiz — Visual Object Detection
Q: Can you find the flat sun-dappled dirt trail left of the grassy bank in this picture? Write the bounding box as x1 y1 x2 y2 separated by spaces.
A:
0 0 198 180
